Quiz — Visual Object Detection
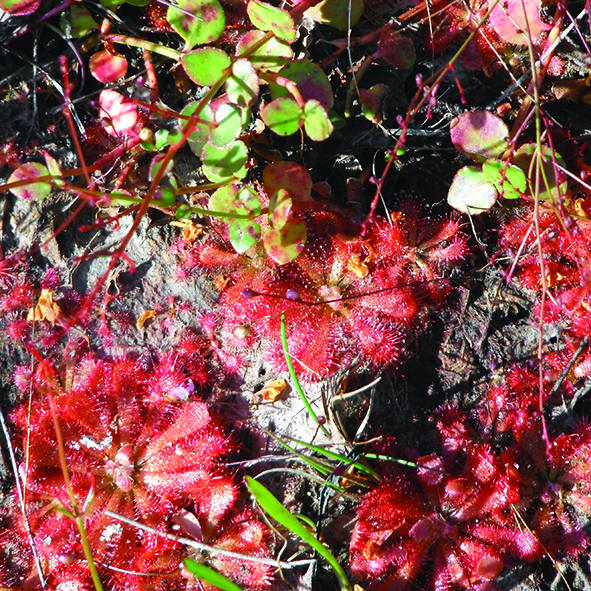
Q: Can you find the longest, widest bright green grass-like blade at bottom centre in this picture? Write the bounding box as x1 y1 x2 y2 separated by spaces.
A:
246 476 351 591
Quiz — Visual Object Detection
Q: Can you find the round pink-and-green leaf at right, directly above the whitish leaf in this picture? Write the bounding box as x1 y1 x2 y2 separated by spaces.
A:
449 110 509 162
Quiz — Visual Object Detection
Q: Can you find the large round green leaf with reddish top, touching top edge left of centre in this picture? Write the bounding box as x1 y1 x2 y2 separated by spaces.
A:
166 0 226 49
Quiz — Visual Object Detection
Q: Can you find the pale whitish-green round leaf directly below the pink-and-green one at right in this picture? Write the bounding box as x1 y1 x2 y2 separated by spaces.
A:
447 166 497 215
